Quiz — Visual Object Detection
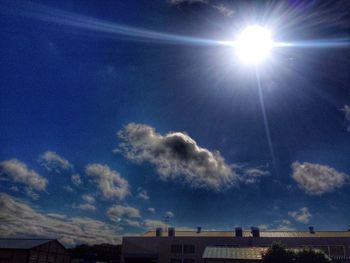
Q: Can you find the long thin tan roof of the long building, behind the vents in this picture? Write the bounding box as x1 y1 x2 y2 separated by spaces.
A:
142 229 350 238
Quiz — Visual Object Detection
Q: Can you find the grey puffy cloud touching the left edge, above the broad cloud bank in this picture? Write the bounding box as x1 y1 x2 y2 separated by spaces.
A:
0 159 47 191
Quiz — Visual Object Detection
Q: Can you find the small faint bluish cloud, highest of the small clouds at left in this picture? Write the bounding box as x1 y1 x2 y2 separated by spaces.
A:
39 151 72 172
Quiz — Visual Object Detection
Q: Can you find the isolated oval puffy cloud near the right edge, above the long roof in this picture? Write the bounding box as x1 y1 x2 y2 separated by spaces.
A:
292 162 349 195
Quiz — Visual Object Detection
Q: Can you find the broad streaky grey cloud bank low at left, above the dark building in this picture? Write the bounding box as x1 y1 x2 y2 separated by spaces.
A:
0 193 121 246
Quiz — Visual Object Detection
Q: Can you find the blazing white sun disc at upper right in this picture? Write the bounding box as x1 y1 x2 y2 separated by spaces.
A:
235 25 273 65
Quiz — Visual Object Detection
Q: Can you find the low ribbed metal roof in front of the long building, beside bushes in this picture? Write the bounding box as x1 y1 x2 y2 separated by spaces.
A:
202 247 268 260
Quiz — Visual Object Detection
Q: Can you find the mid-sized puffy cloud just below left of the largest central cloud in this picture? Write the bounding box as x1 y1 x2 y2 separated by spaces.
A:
85 164 129 200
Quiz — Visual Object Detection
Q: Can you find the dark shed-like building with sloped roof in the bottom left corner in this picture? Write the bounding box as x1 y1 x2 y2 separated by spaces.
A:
0 239 70 263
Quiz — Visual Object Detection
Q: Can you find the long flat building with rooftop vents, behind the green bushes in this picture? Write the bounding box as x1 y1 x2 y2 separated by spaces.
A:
121 227 350 263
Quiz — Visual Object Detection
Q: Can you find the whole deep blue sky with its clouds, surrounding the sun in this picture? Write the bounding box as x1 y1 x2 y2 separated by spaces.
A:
0 0 350 248
